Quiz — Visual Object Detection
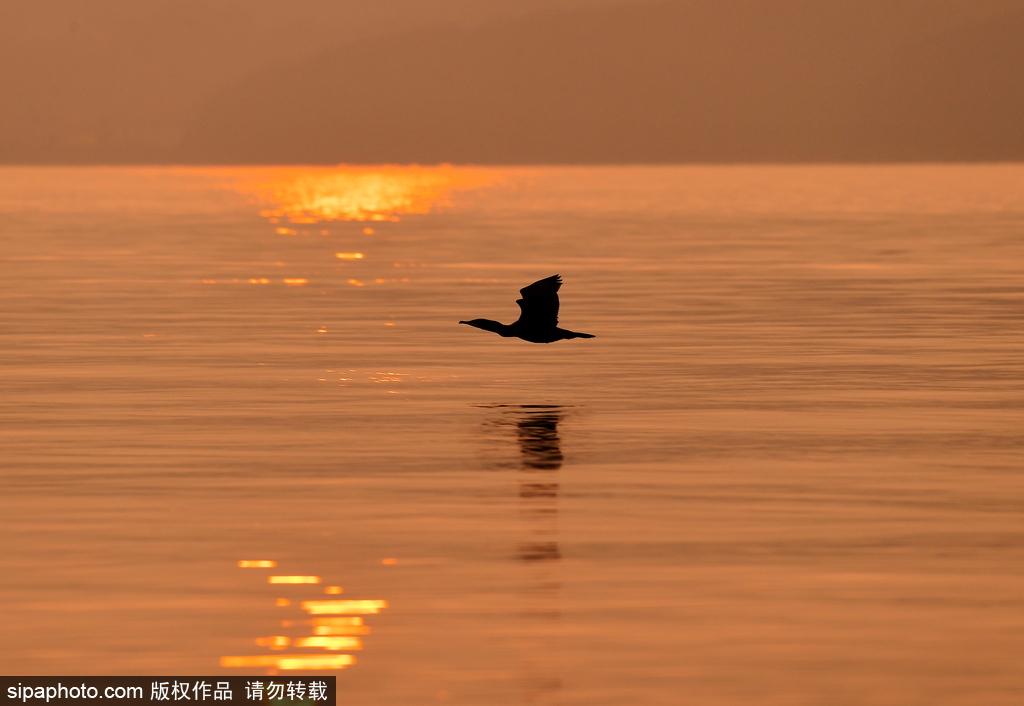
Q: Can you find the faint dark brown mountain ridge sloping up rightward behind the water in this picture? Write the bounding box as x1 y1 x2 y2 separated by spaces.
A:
0 0 1024 163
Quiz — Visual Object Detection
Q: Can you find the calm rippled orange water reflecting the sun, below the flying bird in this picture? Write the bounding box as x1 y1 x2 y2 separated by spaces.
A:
0 166 1024 706
